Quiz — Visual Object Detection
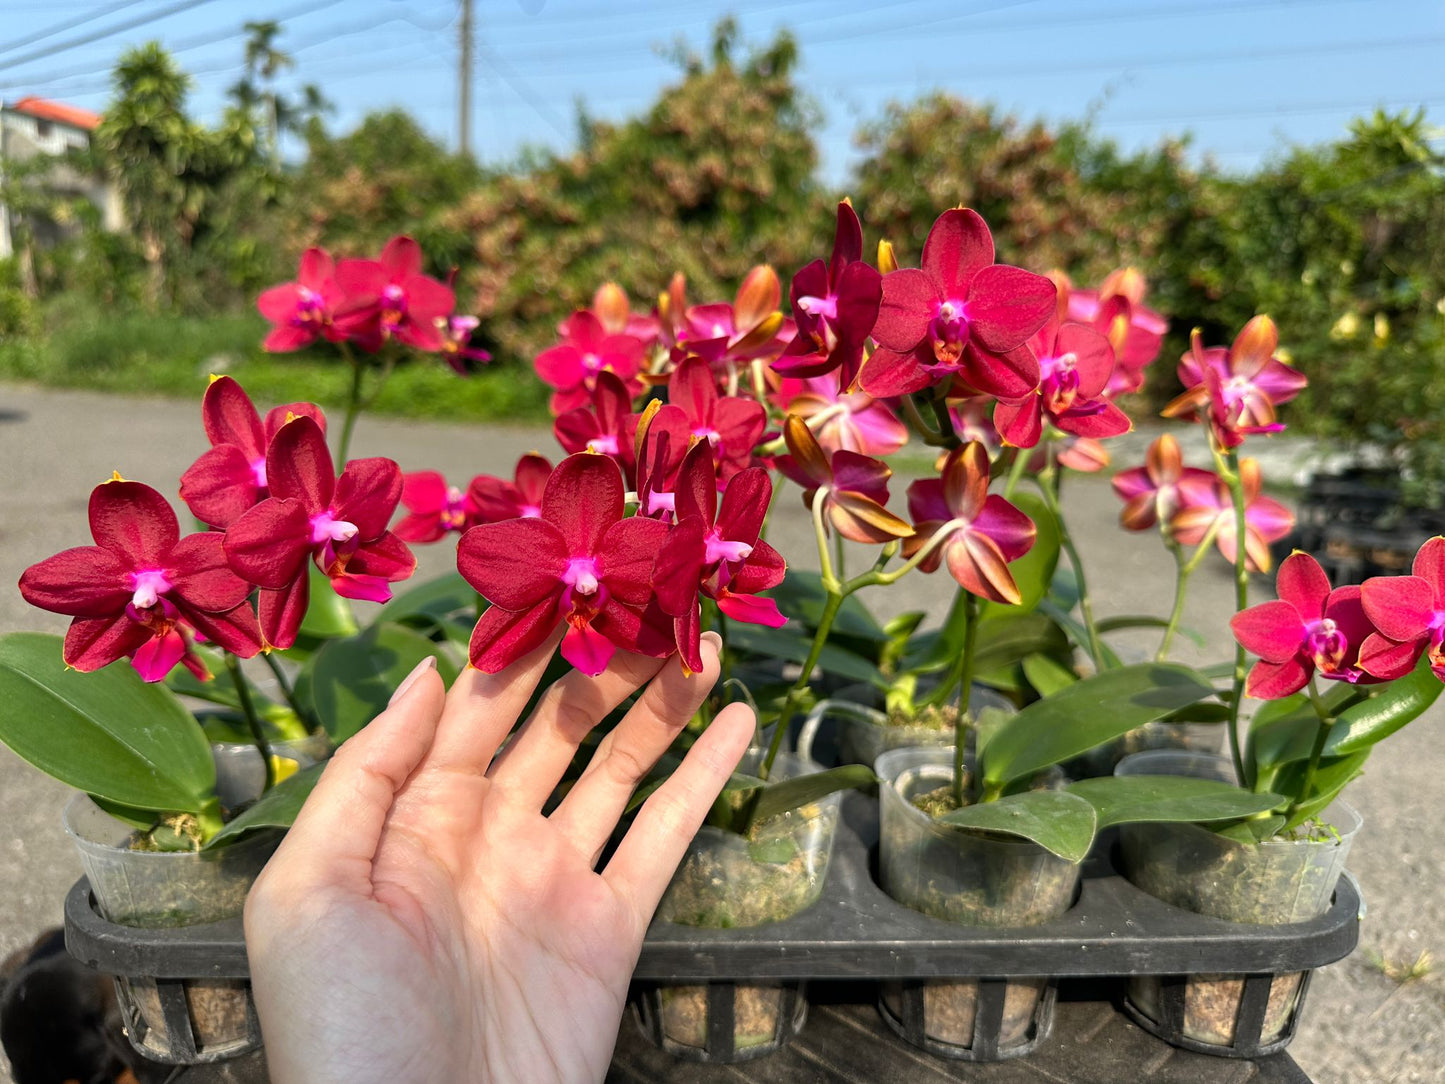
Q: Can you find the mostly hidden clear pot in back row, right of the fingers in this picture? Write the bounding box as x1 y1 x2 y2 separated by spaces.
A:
798 685 1017 765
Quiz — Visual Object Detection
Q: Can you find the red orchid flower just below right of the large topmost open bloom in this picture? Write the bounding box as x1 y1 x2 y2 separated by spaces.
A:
994 319 1133 448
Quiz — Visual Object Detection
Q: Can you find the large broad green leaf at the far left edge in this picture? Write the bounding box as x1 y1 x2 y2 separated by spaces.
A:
0 633 215 812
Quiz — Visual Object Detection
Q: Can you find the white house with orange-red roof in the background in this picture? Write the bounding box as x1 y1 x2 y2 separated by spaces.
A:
0 97 124 259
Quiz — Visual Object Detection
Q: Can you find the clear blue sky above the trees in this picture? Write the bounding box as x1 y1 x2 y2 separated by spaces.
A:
0 0 1445 181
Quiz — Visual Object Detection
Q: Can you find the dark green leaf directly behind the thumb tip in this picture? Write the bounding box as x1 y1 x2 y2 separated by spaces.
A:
311 623 457 744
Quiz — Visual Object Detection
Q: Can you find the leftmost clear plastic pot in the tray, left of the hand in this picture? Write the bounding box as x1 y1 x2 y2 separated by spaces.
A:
65 793 282 1064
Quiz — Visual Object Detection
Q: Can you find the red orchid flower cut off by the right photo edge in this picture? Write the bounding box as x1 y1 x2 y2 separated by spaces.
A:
1360 536 1445 681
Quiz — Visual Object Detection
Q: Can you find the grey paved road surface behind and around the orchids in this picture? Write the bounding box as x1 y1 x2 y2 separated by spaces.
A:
0 386 1445 1084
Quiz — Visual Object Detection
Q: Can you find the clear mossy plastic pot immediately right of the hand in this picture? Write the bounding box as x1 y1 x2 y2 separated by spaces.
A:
636 750 842 1062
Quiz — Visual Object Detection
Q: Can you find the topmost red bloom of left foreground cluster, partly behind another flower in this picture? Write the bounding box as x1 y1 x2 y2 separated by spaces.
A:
181 376 327 528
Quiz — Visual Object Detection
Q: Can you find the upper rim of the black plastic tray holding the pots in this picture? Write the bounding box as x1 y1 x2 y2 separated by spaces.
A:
65 793 1361 981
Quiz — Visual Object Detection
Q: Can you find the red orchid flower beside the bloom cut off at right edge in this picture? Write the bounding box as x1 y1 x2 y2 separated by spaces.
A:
1230 554 1380 700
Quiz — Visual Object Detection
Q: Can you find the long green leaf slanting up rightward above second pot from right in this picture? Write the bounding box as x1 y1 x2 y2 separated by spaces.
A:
981 662 1214 786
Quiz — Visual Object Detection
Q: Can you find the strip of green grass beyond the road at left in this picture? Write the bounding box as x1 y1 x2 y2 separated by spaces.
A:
0 305 548 422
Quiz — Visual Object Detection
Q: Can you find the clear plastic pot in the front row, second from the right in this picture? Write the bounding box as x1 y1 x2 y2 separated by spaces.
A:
876 749 1079 1061
